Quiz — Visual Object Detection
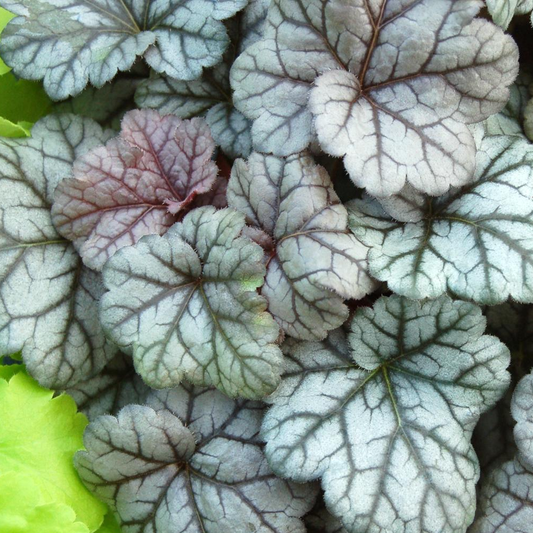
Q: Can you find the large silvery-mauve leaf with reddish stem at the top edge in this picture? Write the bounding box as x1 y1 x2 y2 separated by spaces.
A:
231 0 518 196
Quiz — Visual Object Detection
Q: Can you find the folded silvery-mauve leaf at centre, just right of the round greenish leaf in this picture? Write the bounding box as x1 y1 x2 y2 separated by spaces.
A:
227 153 375 340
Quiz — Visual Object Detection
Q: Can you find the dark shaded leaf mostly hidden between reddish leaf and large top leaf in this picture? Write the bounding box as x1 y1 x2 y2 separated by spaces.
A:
135 55 252 158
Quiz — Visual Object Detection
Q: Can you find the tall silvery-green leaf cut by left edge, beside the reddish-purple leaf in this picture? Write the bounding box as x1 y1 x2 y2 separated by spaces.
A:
0 115 116 389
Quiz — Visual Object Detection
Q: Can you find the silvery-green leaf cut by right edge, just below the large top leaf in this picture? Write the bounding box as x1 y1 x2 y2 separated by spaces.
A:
350 136 533 304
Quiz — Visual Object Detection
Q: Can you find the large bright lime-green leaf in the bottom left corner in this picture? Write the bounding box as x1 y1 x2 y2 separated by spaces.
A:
0 371 106 533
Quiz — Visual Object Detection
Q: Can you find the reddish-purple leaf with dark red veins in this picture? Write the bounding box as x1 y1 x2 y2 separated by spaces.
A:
52 110 218 270
